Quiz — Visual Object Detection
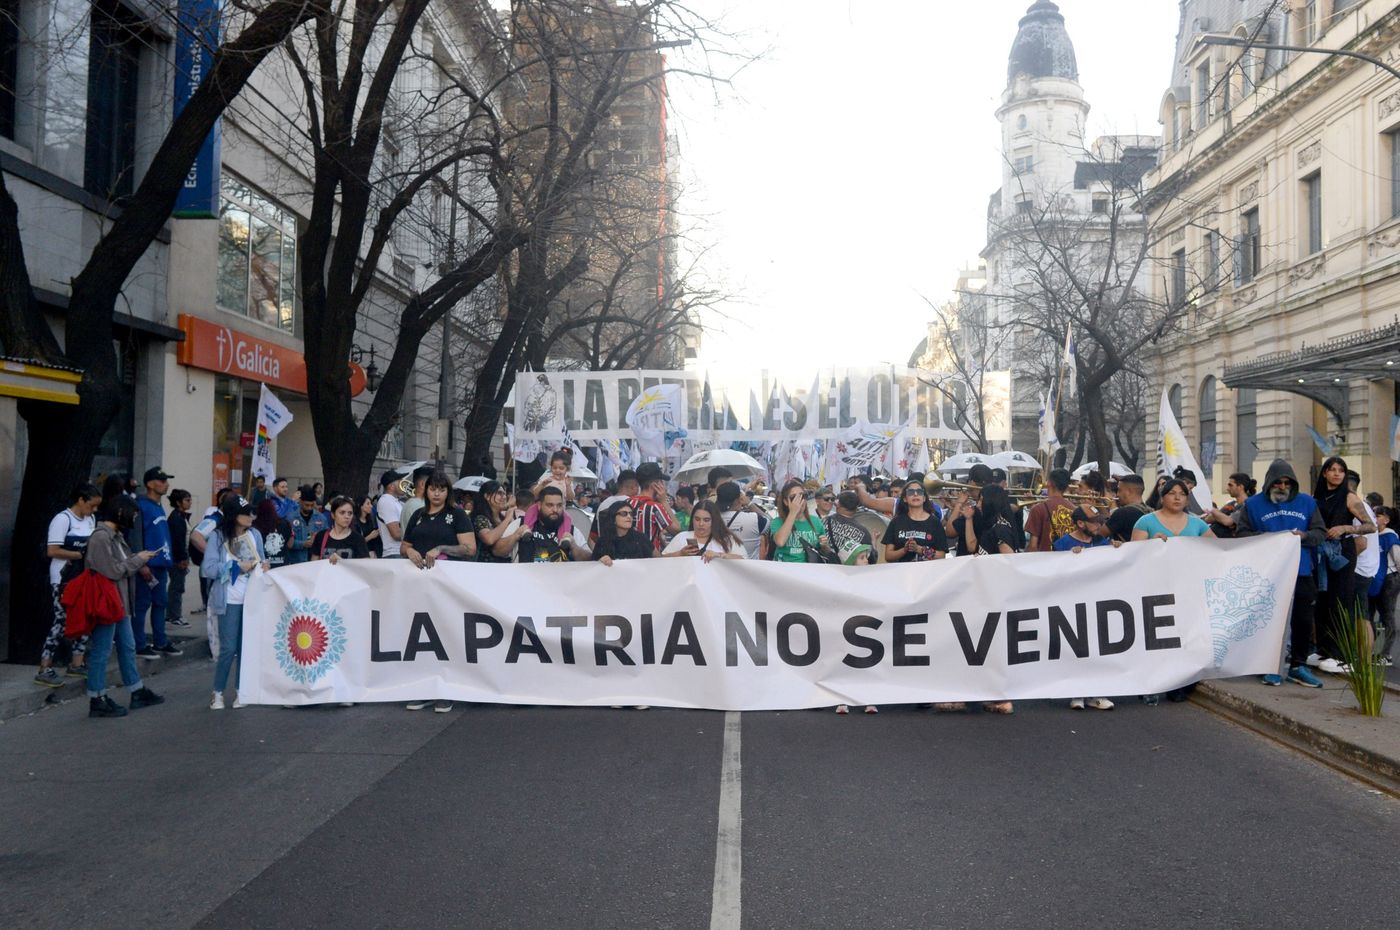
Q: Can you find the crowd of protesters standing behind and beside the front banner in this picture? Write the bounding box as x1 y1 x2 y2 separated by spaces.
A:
35 452 1400 717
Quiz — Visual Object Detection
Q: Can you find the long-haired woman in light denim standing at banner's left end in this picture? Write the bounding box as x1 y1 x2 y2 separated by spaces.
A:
200 497 272 710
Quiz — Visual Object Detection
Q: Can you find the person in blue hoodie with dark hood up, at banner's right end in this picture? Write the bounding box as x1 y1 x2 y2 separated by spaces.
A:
1233 458 1327 688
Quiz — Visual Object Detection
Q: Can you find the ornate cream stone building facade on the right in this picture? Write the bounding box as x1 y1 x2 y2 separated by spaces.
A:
1145 0 1400 500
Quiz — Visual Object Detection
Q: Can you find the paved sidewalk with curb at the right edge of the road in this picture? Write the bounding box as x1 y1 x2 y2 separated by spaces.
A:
1191 668 1400 797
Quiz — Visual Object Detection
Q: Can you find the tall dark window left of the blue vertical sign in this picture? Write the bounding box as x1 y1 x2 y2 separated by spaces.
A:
83 0 148 199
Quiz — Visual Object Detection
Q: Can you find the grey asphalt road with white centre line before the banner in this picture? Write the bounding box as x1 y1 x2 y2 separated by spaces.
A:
0 665 1400 930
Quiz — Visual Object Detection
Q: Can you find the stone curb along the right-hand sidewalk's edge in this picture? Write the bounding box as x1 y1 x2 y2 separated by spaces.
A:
1191 681 1400 798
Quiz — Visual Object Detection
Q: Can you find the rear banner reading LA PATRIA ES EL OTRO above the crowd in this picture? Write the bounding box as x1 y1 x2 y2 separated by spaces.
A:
514 366 1011 441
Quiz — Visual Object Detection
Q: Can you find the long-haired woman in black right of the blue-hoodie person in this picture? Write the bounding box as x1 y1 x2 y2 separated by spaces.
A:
1309 455 1376 674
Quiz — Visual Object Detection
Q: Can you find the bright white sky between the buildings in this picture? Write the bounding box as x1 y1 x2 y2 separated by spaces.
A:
668 0 1179 368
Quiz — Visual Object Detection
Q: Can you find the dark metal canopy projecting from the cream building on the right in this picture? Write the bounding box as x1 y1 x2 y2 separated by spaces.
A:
1221 322 1400 426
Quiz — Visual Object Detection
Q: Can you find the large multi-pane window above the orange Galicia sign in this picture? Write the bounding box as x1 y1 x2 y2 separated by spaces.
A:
217 174 301 335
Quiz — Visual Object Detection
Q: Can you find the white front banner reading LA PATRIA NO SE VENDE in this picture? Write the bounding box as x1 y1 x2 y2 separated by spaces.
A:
239 534 1299 710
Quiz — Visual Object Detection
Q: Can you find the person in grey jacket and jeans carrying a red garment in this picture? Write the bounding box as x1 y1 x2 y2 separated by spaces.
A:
84 494 165 717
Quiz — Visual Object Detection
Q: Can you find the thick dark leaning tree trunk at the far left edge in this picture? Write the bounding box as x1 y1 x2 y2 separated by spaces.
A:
0 0 325 658
